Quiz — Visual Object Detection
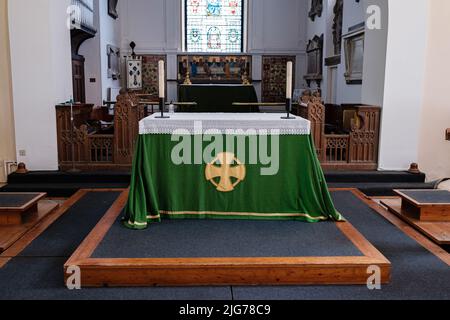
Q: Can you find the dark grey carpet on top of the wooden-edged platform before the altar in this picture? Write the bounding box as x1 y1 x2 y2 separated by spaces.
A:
93 220 362 258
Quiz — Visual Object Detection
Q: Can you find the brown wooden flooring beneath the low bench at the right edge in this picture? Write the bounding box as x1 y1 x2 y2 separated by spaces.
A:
381 198 450 245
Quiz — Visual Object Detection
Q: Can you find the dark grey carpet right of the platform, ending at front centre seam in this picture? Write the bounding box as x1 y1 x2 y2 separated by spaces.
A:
233 192 450 300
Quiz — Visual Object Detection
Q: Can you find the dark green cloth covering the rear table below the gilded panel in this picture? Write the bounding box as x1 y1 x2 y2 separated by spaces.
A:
178 84 259 113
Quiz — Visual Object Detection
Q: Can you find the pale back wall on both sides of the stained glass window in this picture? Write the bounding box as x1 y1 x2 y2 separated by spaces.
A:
119 0 308 100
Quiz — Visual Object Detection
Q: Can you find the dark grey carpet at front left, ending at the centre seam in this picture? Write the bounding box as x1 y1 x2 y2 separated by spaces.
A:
0 257 231 300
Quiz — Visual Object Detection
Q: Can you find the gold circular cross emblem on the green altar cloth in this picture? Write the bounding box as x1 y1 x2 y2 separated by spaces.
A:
205 152 246 192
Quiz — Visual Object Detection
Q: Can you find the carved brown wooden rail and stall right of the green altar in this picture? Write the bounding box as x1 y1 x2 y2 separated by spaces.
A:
294 93 381 170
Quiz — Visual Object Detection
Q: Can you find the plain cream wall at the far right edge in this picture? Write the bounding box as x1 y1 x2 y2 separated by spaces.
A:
419 0 450 180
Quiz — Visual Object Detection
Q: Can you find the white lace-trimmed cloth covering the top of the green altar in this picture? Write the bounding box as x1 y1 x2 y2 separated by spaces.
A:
139 113 311 136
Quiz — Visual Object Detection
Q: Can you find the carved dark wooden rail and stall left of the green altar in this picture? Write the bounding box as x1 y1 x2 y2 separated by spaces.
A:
56 93 148 171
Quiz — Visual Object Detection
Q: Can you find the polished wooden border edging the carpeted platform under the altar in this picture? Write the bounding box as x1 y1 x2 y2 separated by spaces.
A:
65 191 391 287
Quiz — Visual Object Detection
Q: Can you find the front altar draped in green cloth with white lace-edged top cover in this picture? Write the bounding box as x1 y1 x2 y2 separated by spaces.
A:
124 113 343 229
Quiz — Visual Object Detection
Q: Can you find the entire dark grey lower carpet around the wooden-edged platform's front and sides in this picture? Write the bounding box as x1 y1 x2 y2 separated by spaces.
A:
0 192 450 300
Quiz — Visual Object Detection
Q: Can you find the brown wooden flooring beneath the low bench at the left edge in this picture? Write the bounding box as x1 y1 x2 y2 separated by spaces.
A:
0 200 59 253
